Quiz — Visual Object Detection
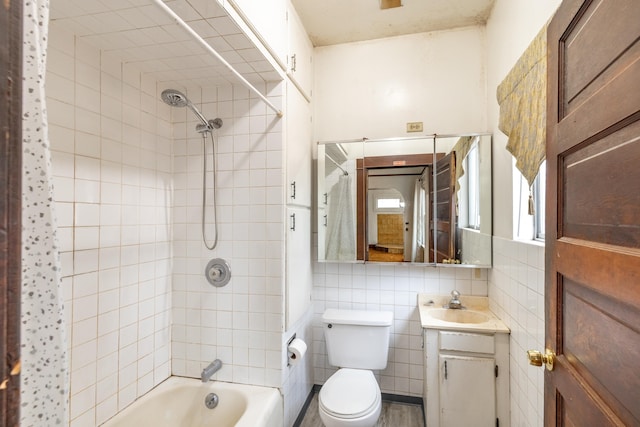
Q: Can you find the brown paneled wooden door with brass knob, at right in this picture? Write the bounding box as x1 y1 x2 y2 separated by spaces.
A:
544 0 640 426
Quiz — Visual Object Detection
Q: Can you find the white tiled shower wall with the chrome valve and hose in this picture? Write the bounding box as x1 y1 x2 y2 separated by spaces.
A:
172 84 284 387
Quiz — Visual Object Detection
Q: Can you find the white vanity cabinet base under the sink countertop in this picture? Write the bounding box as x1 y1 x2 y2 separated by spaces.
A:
424 329 510 427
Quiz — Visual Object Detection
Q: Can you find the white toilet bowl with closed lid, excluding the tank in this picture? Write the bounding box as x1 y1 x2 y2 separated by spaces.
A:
318 368 382 427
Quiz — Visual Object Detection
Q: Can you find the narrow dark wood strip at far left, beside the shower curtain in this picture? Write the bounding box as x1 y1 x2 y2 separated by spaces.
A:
0 1 23 426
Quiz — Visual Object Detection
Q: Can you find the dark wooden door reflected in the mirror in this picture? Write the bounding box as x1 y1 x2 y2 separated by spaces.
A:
429 151 457 264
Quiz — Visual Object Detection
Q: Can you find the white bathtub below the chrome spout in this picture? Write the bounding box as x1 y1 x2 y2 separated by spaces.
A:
102 377 284 427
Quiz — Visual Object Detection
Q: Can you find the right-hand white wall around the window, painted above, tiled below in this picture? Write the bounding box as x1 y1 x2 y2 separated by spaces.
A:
486 0 560 426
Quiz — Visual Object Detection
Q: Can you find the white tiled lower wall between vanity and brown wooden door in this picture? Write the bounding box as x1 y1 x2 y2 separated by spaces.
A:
489 237 544 427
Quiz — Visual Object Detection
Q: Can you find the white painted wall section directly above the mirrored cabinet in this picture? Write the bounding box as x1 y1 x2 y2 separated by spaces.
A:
313 27 486 141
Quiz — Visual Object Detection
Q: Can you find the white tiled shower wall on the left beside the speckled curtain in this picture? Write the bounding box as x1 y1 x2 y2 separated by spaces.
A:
46 24 172 427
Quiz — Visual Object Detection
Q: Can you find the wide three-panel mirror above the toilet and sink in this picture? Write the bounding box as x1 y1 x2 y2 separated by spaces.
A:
317 134 492 267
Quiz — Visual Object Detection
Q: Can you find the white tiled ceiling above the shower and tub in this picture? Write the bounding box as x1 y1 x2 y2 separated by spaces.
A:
50 0 280 88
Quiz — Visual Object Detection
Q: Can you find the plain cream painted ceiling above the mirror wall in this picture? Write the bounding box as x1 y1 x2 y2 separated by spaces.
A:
291 0 495 46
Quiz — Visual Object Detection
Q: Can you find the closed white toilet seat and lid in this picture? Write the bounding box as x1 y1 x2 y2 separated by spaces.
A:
318 368 381 419
